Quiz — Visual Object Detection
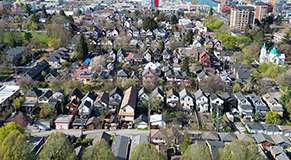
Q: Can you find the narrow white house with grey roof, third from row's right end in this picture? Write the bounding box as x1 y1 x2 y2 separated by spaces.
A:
234 92 253 120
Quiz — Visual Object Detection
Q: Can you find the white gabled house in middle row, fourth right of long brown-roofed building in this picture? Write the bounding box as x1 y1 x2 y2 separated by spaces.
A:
179 88 195 113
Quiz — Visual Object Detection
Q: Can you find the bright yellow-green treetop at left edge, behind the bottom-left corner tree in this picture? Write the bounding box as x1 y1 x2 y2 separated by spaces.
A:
0 122 24 146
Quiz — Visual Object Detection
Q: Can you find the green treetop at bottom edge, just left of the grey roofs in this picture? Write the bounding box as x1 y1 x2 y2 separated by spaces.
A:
82 138 116 160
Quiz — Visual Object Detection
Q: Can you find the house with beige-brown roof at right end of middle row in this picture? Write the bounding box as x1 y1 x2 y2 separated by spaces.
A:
262 93 284 117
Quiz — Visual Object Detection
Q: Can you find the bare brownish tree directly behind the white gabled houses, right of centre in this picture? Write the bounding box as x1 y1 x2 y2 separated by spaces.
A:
199 75 224 93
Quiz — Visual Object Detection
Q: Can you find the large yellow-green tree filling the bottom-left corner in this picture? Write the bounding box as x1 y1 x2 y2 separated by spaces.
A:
0 130 31 160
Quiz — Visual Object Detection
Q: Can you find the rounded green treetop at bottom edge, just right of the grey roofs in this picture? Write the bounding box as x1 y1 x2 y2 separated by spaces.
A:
130 143 165 160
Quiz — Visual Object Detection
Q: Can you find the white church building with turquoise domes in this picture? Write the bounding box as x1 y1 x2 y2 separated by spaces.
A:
260 44 285 66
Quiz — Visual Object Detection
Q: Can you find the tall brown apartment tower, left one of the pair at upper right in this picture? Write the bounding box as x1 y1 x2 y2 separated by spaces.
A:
230 5 255 31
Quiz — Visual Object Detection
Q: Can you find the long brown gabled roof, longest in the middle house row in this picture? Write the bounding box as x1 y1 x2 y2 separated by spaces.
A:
120 87 137 109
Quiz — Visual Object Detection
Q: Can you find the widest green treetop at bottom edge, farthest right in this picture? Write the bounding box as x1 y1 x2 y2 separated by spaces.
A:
216 140 264 160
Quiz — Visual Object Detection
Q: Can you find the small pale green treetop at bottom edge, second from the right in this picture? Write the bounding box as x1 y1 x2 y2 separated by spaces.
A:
181 144 212 160
